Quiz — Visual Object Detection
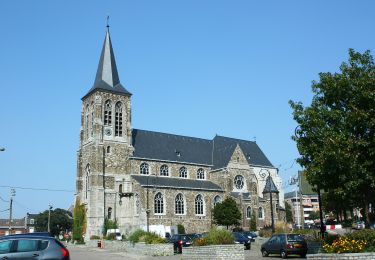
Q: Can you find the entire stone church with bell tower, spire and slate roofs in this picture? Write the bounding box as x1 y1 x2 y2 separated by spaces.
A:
76 30 285 238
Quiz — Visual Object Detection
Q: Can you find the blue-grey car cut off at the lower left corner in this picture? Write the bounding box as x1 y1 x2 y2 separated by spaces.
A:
0 234 70 260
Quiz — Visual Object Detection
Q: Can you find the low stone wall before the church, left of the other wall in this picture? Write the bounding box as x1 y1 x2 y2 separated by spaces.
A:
86 240 174 256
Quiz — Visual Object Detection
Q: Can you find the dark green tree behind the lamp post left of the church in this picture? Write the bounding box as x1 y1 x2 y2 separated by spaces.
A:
35 208 73 236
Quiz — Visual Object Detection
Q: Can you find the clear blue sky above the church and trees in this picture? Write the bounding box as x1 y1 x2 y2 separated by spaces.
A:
0 0 375 218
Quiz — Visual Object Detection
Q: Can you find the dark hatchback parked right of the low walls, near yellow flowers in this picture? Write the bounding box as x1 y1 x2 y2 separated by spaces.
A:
260 234 307 258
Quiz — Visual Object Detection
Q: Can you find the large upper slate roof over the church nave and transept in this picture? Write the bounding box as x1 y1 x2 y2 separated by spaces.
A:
132 129 273 169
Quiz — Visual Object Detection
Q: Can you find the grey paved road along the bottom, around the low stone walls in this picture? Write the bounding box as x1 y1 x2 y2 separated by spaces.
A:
68 241 301 260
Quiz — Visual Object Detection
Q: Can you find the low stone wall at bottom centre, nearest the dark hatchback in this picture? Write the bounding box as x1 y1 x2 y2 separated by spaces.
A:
182 244 245 260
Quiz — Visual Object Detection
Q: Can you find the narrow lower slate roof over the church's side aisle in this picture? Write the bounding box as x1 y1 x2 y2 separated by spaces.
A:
131 175 224 192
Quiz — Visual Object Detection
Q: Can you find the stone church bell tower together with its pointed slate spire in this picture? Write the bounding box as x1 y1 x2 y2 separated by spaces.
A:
76 26 133 239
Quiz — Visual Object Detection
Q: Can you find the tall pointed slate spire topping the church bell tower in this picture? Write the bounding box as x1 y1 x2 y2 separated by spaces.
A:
83 26 131 98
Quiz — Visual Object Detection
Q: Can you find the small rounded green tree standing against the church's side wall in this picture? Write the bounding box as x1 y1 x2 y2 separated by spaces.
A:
214 197 241 229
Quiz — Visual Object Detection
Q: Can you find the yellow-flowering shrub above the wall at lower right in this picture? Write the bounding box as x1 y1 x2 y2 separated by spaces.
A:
323 237 366 254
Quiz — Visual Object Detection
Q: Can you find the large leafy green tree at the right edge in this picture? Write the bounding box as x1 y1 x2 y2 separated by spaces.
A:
289 49 375 225
